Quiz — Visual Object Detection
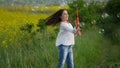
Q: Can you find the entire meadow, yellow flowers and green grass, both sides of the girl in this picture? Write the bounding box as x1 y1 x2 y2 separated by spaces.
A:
0 6 119 68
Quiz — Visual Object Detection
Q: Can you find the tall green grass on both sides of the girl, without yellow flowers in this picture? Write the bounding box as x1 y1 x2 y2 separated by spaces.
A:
0 26 102 68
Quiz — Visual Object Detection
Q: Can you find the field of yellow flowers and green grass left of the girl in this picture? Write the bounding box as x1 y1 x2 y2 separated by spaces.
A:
0 6 67 68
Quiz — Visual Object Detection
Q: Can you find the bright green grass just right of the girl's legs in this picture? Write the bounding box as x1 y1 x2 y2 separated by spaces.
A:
74 28 103 68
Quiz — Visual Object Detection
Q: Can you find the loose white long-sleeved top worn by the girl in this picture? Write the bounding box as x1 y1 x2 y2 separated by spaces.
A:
56 22 76 46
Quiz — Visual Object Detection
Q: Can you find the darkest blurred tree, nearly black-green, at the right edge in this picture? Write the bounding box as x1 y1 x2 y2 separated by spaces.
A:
99 0 120 45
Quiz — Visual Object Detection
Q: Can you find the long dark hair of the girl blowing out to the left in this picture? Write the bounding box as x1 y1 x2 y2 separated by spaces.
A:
45 9 66 26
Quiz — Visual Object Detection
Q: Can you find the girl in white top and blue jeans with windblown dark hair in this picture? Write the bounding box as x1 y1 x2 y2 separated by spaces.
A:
45 9 80 68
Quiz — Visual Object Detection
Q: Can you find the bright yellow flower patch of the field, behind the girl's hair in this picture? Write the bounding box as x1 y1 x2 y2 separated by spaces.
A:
0 6 61 47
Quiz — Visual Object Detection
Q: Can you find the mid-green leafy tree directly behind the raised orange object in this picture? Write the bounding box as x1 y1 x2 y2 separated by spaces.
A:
69 0 101 29
